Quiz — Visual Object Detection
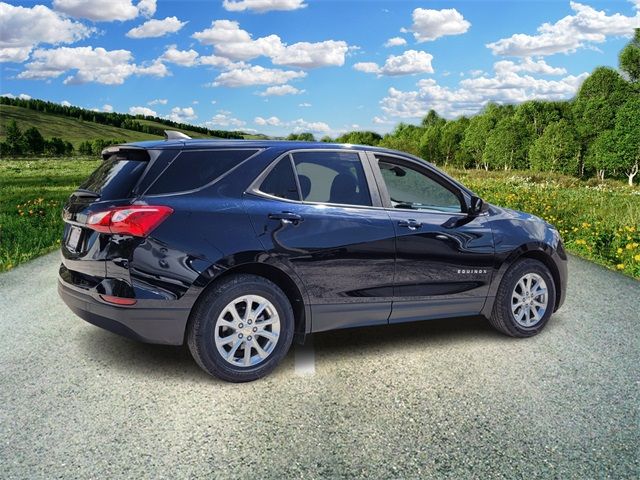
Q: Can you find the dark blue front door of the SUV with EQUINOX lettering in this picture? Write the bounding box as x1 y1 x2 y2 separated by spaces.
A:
369 153 494 323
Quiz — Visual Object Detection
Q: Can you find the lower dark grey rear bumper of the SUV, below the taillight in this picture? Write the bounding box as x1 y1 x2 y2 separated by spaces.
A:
58 277 191 345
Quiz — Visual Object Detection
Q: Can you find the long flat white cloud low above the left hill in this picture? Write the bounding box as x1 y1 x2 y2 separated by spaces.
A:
18 47 168 85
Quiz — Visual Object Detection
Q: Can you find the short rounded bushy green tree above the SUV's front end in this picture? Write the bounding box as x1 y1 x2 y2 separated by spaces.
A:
529 120 580 175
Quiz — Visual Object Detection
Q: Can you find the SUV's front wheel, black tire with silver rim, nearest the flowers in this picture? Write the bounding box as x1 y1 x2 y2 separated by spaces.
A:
489 258 556 337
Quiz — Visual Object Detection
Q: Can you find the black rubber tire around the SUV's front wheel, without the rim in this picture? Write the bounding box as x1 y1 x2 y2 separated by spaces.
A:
489 258 556 337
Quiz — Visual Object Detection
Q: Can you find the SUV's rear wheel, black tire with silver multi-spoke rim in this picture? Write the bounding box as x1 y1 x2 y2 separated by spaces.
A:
187 274 294 382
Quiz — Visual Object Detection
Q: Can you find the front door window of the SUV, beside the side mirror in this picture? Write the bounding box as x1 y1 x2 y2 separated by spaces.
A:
379 161 461 212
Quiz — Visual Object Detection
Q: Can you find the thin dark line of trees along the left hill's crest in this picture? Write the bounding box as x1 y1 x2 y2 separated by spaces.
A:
0 97 244 139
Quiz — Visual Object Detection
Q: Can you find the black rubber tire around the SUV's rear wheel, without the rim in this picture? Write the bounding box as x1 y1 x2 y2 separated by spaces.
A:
187 274 294 382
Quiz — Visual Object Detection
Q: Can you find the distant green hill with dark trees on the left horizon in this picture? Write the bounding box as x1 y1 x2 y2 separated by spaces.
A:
0 97 260 148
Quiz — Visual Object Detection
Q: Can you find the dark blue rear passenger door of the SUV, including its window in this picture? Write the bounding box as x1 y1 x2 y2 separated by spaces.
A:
245 150 395 332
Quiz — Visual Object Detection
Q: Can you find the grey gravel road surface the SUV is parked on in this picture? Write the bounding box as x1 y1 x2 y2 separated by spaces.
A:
0 253 640 479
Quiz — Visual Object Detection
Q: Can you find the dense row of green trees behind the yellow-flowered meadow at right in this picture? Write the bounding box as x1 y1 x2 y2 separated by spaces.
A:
321 29 640 185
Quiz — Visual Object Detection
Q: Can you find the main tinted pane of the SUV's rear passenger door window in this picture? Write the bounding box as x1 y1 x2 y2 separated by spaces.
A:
293 152 371 205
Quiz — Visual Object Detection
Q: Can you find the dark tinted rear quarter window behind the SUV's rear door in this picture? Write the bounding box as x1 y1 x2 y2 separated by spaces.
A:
146 150 256 195
